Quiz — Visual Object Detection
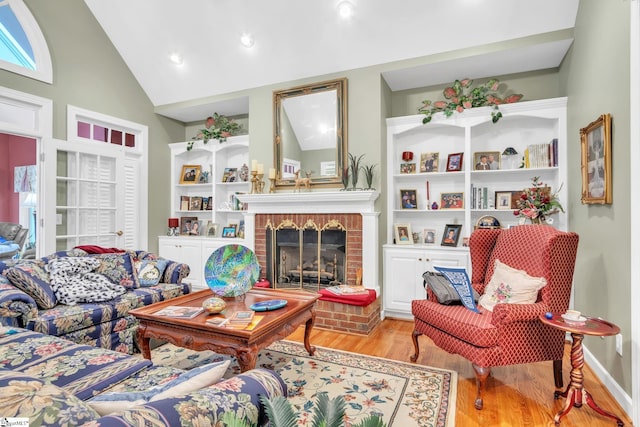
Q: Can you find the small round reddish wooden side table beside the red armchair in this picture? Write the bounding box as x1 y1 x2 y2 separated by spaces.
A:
540 313 624 427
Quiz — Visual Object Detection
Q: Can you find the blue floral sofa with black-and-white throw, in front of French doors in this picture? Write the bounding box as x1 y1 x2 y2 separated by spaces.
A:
0 248 191 354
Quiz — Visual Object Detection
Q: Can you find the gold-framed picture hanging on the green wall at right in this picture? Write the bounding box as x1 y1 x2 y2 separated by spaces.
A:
580 113 613 205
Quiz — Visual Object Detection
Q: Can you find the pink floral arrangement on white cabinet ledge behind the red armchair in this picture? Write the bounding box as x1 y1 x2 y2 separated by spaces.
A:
513 176 564 224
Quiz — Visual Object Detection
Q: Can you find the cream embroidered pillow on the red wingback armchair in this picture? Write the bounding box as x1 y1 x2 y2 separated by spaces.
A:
478 260 547 311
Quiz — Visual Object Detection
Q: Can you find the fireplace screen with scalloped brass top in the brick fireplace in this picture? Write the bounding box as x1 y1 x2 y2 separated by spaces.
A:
266 221 347 291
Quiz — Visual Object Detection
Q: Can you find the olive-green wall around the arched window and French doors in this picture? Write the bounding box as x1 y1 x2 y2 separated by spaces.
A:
0 0 184 251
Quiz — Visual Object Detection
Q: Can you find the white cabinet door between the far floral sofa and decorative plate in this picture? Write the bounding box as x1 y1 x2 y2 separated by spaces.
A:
158 237 204 289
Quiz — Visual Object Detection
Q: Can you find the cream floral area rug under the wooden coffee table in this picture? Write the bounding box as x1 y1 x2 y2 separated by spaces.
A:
151 341 457 427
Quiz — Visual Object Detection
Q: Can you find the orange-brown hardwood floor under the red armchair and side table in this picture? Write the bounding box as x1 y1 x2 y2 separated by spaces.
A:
287 319 632 427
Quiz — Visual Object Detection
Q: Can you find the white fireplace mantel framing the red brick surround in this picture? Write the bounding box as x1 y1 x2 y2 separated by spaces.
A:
237 191 380 294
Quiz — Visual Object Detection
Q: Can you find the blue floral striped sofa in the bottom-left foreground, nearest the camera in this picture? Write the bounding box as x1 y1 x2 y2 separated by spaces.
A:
0 328 287 427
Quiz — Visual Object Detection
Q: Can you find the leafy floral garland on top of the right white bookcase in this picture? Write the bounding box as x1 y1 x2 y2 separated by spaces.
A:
418 79 523 124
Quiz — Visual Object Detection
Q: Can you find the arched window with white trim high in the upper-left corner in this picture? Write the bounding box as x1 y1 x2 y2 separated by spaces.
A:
0 0 53 83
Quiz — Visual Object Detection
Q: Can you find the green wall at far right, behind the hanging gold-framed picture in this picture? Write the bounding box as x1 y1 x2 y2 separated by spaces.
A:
560 0 637 395
